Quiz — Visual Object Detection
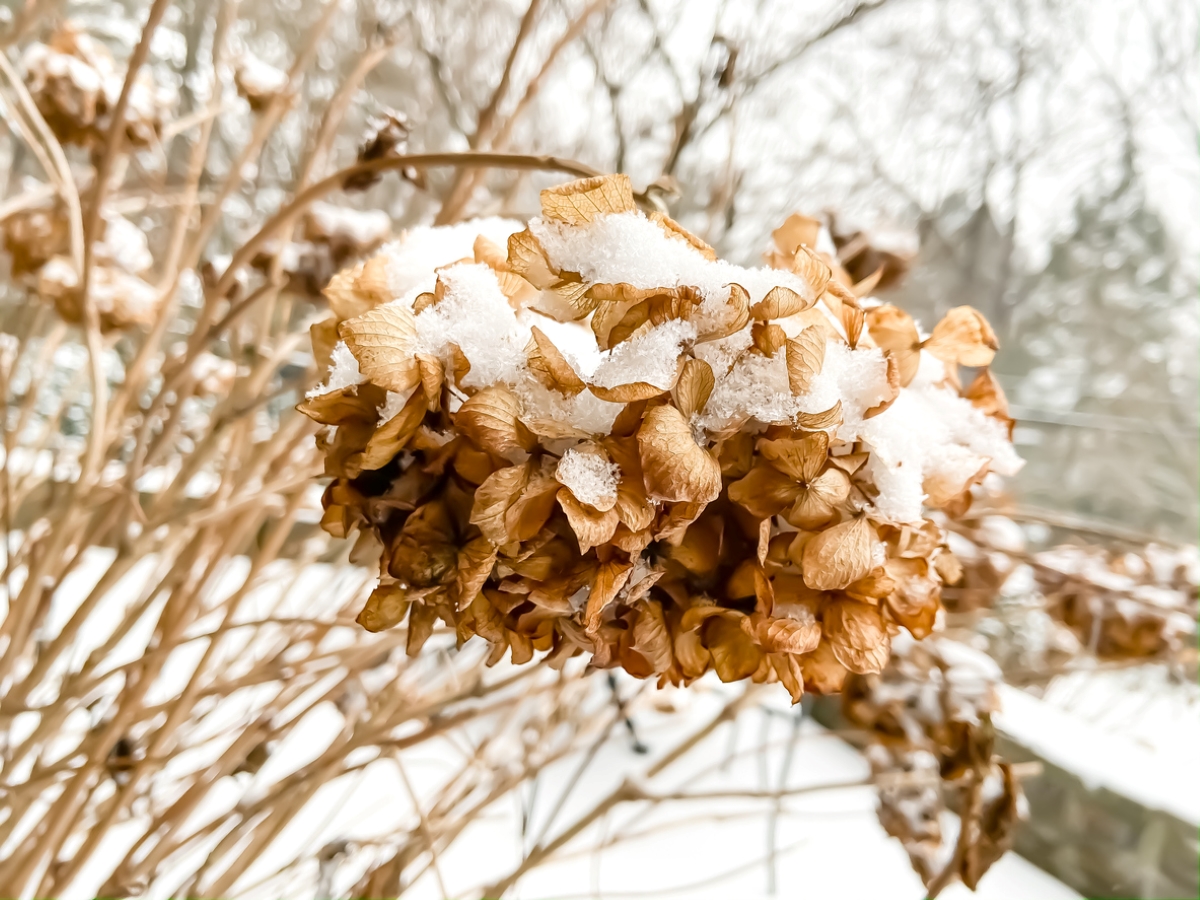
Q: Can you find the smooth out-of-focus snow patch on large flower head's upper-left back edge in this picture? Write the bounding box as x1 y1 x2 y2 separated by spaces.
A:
380 217 524 299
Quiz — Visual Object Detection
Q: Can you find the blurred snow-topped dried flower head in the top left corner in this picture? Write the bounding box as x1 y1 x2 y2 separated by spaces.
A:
23 22 175 150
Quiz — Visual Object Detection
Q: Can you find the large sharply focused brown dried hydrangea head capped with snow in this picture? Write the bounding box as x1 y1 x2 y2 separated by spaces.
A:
300 175 1020 700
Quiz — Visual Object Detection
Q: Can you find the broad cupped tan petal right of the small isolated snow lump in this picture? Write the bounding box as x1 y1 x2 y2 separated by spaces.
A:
637 406 721 503
